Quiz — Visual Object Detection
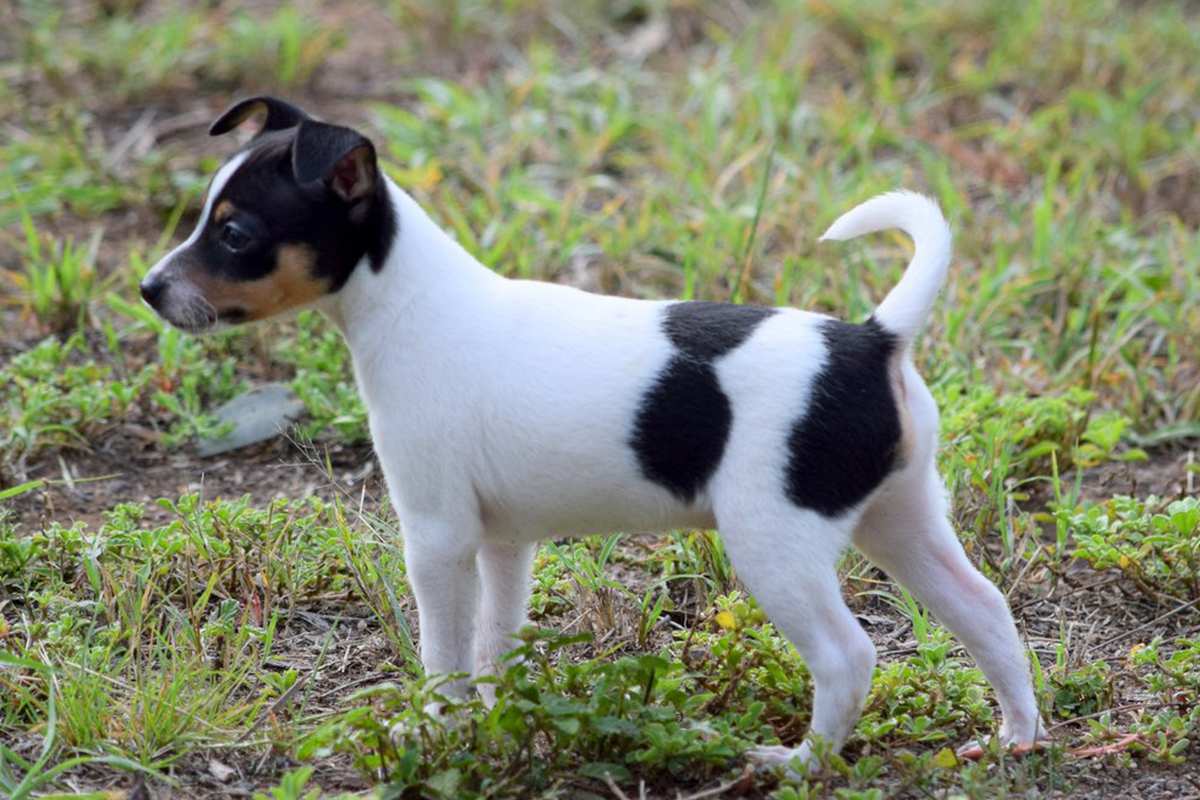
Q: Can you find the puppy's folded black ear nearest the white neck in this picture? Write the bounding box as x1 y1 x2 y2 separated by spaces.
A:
292 120 379 203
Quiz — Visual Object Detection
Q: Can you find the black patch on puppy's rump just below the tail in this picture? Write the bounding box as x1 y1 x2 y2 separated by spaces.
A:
786 318 900 517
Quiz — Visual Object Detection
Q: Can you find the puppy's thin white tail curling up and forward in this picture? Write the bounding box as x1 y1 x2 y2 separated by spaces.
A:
821 191 950 343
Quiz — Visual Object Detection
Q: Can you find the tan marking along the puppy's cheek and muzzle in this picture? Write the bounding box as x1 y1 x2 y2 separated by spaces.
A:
186 245 329 321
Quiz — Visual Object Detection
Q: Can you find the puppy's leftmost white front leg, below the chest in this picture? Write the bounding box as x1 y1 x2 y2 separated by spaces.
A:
401 516 481 697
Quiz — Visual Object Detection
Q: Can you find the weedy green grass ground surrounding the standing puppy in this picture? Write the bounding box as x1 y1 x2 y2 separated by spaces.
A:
0 0 1200 800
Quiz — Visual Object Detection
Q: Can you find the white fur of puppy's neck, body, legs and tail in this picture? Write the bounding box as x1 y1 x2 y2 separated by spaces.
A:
302 184 1040 762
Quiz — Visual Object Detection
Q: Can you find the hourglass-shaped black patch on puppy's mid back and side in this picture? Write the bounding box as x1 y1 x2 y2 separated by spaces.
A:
629 302 775 503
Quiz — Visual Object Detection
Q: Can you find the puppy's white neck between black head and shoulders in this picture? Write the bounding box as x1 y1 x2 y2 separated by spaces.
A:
318 178 503 362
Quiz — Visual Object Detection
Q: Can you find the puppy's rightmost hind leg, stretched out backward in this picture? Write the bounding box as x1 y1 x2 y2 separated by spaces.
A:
854 463 1044 748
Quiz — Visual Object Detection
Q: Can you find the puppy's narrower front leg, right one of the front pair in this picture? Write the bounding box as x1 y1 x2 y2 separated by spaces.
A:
473 541 538 706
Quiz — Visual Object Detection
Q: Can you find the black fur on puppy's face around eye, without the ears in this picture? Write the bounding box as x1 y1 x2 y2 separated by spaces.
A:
204 128 396 291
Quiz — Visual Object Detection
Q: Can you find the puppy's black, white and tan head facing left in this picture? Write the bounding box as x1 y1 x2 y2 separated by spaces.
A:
142 97 395 332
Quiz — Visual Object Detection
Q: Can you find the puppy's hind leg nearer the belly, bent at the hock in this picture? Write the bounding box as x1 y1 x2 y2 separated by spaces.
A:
716 501 875 765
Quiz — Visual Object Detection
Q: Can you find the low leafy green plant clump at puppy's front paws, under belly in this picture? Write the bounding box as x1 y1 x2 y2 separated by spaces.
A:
299 628 762 798
